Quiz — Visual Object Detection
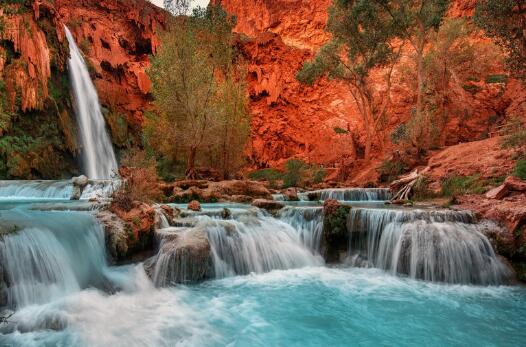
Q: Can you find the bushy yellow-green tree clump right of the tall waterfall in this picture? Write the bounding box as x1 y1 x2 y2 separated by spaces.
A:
145 6 249 178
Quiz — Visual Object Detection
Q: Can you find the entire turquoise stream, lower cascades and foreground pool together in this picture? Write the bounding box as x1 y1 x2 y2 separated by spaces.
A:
0 188 526 347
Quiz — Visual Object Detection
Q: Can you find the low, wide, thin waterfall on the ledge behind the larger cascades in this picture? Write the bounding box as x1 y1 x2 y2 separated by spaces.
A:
298 188 391 201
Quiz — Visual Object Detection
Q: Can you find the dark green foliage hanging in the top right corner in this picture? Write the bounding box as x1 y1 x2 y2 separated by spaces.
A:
475 0 526 80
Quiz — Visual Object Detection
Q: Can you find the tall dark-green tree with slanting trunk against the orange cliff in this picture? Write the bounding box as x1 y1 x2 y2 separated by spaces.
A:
297 0 402 159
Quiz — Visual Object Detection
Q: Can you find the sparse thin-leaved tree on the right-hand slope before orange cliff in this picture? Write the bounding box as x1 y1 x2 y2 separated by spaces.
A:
400 18 501 153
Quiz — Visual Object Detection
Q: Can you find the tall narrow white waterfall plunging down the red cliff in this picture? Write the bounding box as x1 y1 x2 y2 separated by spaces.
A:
64 27 117 179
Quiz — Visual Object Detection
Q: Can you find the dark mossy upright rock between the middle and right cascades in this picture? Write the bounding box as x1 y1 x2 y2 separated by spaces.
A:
321 200 351 263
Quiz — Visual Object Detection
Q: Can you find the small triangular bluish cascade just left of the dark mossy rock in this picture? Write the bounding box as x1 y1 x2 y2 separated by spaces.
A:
278 206 323 254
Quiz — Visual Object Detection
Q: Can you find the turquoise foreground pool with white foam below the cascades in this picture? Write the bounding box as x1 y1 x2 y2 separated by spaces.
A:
0 267 526 346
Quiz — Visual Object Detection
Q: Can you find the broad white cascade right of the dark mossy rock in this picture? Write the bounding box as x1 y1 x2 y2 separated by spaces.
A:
348 208 509 285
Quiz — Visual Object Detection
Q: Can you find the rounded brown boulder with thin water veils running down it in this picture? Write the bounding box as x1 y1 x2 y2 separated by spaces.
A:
144 228 213 287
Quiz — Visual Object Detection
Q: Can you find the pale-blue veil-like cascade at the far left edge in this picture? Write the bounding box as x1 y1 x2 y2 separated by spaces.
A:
0 210 110 307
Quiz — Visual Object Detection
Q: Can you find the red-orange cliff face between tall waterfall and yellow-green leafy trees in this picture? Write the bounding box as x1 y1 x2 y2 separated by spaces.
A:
55 0 165 126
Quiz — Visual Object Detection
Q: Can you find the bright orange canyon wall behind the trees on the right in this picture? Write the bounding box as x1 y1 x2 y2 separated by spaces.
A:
212 0 526 167
